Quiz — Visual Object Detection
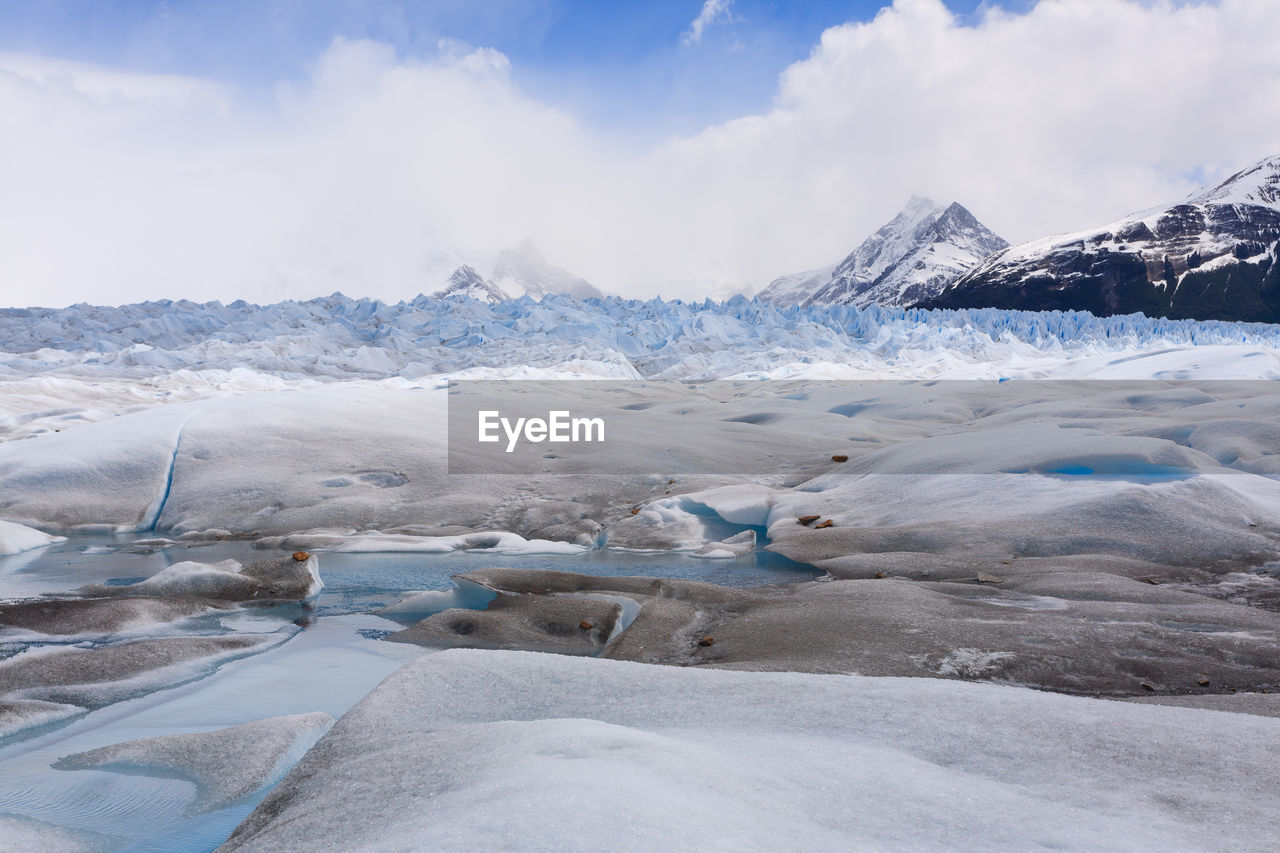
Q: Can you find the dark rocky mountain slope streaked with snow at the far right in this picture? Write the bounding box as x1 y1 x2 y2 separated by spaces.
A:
927 156 1280 323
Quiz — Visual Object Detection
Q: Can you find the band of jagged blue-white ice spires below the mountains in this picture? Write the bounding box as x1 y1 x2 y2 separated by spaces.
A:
0 293 1280 391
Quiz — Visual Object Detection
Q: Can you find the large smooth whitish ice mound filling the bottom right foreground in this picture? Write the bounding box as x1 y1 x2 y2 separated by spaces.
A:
220 651 1280 853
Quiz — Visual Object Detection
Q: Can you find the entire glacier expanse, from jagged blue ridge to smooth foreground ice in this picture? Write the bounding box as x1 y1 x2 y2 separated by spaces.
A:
0 293 1280 849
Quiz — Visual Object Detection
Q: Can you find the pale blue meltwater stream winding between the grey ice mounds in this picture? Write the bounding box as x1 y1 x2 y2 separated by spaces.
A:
0 534 820 853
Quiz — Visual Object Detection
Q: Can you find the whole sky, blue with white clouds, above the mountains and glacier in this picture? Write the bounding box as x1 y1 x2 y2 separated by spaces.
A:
0 0 1280 306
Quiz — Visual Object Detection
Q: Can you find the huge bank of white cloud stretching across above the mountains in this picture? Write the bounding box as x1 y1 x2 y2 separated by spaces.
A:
0 0 1280 305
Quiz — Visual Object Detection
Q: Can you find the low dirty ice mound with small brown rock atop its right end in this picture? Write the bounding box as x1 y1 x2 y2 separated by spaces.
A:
79 552 324 602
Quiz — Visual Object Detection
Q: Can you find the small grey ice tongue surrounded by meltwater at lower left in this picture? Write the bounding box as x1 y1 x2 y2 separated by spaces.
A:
54 712 334 815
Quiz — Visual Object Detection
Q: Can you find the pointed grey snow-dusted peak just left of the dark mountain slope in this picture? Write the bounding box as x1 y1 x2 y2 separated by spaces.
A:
759 196 1009 306
